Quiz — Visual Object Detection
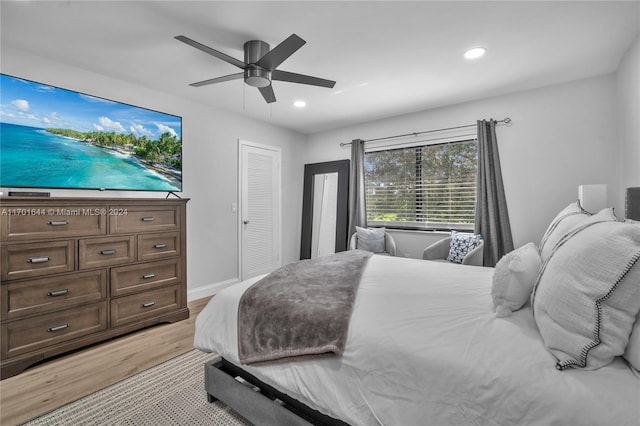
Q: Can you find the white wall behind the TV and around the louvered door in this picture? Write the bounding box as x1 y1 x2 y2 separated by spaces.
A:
2 48 306 300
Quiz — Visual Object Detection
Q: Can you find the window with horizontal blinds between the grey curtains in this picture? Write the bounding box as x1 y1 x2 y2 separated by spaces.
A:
364 140 478 230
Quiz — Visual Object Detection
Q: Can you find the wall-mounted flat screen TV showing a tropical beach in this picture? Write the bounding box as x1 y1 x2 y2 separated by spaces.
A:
0 74 182 192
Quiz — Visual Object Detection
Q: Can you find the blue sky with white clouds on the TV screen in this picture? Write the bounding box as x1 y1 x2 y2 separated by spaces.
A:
0 74 181 140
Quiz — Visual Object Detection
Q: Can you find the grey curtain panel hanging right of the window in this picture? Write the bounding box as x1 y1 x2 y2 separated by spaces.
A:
475 119 513 266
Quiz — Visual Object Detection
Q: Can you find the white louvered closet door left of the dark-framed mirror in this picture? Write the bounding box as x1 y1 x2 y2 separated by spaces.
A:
239 141 281 280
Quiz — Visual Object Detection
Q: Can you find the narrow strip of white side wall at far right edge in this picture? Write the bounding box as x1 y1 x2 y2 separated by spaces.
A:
615 36 640 216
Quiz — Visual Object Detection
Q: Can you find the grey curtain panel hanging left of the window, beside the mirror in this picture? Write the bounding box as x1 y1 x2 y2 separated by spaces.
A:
349 139 367 237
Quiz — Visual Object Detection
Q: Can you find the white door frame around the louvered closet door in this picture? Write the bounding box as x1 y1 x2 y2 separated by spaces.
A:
237 139 282 281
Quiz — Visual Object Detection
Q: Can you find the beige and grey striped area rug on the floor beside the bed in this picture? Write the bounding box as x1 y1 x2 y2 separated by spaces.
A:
25 349 251 426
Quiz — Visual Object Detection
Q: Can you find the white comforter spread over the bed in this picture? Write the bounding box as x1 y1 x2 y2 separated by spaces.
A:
194 256 640 426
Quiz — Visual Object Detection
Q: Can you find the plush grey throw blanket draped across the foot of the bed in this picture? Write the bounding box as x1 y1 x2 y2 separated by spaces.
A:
238 250 372 364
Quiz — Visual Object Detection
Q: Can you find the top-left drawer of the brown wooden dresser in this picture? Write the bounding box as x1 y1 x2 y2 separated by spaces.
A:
0 205 107 241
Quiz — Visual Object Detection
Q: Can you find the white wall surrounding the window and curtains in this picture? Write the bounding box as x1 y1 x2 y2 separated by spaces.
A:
305 74 622 253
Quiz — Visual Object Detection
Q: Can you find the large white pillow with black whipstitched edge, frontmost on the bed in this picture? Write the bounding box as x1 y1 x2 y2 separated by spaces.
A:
532 210 640 370
